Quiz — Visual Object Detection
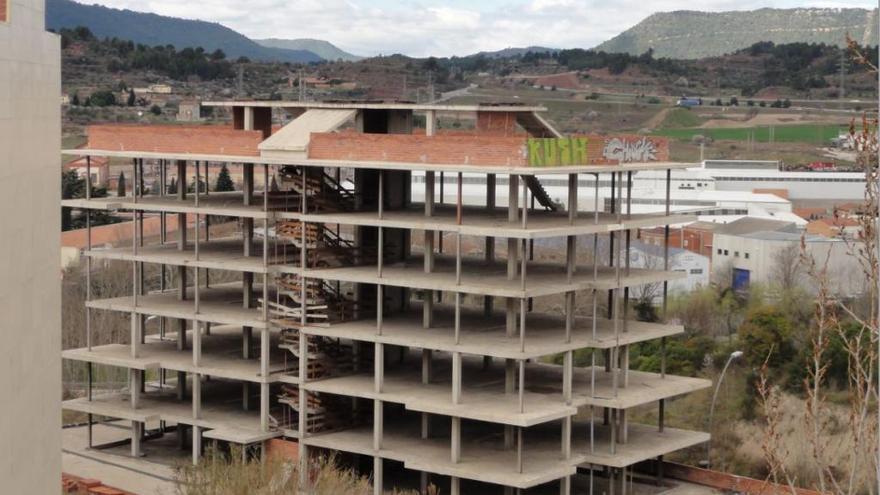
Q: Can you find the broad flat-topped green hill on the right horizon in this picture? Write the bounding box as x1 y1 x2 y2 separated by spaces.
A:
596 8 878 59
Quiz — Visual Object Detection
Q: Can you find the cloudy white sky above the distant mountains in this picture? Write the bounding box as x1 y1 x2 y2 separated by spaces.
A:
78 0 876 57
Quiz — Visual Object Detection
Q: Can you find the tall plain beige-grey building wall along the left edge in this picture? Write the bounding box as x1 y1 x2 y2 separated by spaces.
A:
0 0 61 494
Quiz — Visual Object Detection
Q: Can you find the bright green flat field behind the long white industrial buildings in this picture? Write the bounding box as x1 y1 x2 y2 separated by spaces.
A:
654 125 847 144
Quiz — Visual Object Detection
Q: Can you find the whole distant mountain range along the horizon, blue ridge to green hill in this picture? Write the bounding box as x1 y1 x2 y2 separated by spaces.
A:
46 0 878 63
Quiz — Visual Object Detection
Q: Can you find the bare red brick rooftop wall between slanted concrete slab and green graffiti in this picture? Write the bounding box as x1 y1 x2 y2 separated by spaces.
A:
309 133 527 166
